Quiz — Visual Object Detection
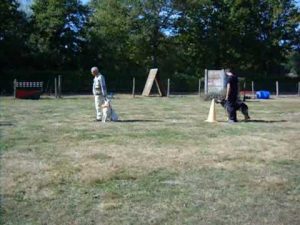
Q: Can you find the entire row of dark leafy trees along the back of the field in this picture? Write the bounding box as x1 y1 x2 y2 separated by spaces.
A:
0 0 300 92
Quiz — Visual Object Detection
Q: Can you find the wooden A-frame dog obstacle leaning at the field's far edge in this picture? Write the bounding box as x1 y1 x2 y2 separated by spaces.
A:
142 68 166 97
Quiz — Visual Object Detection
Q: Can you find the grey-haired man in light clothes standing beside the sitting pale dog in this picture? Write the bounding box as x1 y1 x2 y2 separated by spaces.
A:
91 67 107 121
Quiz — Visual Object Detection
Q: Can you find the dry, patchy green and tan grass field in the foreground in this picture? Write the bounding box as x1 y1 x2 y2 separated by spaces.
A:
0 95 300 225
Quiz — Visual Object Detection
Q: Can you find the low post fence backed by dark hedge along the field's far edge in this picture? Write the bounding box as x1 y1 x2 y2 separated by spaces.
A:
0 71 300 95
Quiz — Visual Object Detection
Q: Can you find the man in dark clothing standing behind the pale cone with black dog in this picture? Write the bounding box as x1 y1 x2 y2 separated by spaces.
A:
225 71 238 123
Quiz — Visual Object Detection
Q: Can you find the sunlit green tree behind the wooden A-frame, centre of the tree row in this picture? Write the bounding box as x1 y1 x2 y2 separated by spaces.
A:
89 0 183 81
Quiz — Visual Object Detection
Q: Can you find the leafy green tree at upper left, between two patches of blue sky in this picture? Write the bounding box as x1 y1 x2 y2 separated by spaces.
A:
30 0 89 68
